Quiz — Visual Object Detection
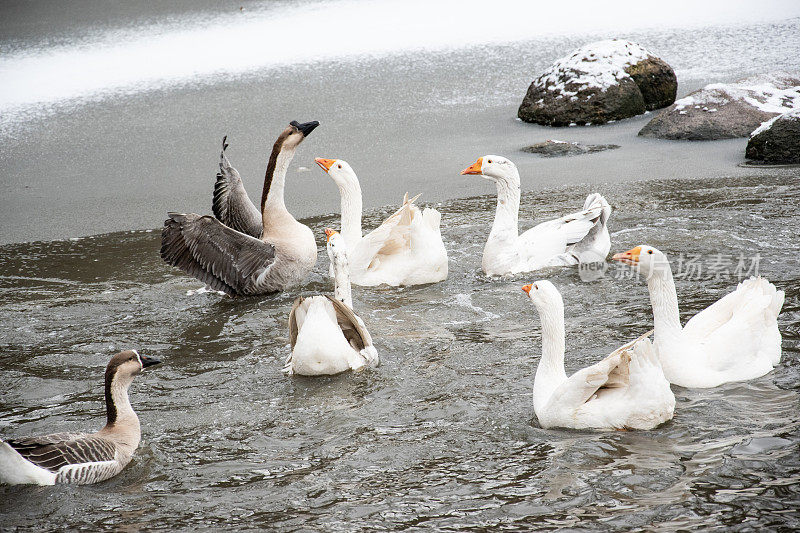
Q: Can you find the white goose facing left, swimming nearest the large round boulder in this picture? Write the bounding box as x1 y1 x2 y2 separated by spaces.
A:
461 155 611 276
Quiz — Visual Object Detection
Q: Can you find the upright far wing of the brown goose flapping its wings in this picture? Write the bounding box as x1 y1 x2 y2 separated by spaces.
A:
211 136 263 239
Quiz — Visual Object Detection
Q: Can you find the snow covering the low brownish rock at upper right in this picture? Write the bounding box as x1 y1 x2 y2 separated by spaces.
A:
675 72 800 114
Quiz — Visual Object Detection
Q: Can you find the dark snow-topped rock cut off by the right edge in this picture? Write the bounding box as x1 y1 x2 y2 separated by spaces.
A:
745 107 800 165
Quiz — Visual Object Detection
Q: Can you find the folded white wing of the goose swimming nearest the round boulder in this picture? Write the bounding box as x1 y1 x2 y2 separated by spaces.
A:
519 193 605 255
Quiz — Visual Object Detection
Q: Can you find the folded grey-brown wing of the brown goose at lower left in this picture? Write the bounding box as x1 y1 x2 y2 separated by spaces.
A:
6 433 114 472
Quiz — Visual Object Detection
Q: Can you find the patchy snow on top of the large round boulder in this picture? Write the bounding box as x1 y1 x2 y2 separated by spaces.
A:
534 39 655 99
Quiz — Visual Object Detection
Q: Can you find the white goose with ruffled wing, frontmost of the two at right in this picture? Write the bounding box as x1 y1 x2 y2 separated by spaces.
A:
522 280 675 430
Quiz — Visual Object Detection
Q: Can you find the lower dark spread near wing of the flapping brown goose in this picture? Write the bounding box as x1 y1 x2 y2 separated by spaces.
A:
161 213 275 296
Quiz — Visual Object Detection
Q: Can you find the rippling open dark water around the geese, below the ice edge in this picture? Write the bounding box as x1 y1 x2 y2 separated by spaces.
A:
0 172 800 531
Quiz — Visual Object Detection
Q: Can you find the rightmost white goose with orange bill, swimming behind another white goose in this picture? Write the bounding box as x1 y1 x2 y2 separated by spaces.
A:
612 245 784 388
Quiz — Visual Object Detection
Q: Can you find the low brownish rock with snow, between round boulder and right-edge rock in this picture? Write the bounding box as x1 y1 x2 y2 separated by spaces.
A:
639 73 800 140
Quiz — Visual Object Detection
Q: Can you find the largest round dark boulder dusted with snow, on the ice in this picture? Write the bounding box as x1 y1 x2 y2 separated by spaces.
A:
517 39 678 126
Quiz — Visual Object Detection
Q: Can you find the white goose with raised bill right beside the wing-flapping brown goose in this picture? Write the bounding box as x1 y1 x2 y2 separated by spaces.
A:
315 157 448 287
